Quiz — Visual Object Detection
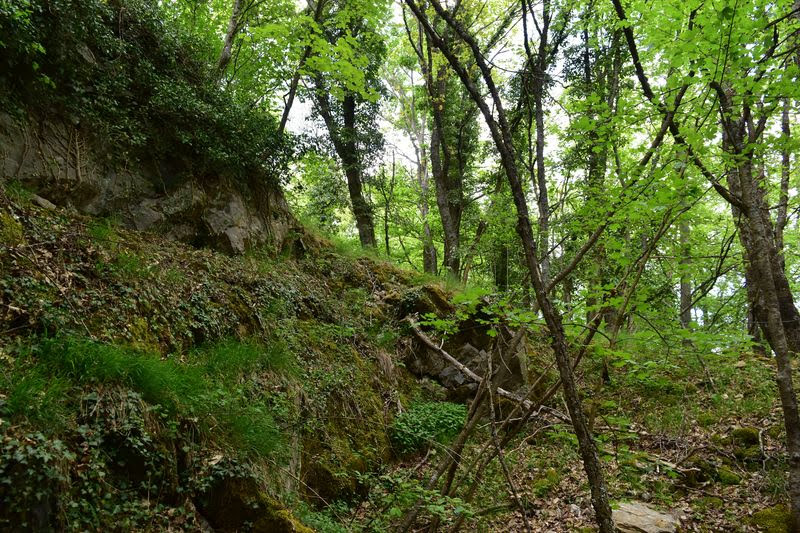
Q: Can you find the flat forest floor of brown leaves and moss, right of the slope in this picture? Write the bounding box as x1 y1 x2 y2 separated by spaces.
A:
340 332 788 532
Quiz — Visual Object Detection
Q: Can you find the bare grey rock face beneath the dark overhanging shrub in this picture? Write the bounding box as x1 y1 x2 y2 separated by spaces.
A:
0 114 296 253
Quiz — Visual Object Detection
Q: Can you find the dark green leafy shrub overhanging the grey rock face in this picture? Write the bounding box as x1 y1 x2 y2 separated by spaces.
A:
0 0 292 184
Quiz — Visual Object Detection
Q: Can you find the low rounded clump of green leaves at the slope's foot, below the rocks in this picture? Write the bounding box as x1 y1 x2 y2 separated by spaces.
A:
391 402 467 454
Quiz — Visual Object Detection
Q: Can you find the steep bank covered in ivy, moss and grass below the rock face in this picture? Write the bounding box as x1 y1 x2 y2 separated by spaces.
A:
0 191 441 531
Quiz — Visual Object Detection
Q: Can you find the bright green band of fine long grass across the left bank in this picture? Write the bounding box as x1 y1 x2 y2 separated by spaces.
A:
2 337 293 456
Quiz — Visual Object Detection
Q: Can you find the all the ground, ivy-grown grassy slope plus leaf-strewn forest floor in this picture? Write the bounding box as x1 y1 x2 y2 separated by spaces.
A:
0 188 785 532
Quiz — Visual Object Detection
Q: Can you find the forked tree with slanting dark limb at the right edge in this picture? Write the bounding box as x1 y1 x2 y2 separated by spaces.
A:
612 0 800 531
